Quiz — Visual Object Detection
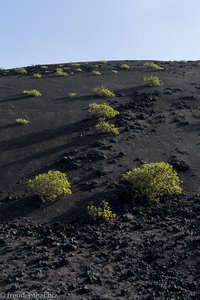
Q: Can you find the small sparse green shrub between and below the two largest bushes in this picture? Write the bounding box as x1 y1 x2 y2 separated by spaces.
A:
87 200 116 222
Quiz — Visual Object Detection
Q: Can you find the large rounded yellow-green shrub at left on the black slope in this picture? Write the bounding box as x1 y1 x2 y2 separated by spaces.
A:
28 171 72 202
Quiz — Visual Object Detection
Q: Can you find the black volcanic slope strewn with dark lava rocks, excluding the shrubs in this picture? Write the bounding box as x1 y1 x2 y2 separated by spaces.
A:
0 61 200 300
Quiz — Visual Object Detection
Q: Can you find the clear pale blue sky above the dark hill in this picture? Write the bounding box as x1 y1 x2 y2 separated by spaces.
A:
0 0 200 68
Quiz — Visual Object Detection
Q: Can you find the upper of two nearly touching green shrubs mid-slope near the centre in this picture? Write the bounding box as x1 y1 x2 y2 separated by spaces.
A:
89 103 119 119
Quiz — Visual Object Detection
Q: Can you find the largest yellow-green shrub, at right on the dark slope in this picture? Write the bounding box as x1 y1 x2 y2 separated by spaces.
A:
123 162 182 203
